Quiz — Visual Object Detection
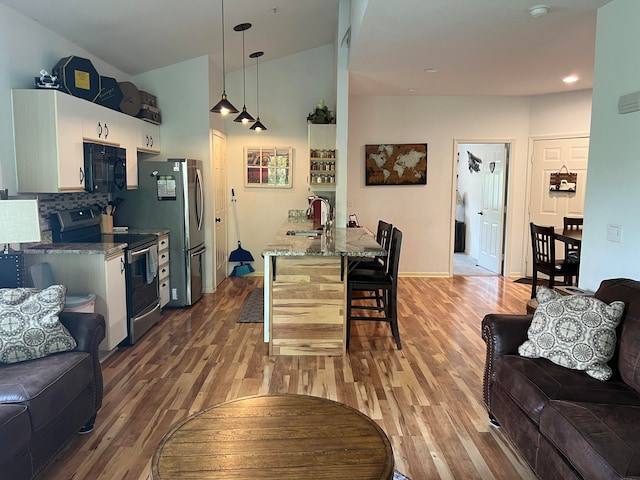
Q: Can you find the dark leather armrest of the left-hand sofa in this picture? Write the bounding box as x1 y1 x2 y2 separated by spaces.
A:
60 312 106 412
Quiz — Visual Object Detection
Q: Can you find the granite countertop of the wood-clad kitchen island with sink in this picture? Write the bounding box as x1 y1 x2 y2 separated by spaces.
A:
262 220 386 257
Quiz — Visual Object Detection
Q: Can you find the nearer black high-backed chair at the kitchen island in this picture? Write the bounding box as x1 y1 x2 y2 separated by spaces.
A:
346 228 402 350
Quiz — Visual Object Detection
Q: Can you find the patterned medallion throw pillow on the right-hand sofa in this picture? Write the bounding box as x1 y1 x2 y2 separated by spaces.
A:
518 286 624 380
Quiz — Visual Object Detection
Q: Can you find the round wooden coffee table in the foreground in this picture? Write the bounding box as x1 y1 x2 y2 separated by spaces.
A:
151 394 393 480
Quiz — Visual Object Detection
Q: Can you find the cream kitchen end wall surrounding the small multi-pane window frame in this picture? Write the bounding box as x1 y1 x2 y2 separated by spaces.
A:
226 45 335 272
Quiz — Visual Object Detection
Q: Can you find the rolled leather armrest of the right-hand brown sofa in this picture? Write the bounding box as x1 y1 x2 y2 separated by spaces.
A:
482 313 533 415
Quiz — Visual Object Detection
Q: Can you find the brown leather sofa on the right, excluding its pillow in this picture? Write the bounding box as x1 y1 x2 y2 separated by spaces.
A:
482 278 640 480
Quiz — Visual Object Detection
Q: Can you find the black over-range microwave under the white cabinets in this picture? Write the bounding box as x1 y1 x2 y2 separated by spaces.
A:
83 142 127 193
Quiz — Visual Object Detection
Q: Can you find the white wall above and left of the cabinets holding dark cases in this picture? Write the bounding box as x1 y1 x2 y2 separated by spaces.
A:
0 4 130 195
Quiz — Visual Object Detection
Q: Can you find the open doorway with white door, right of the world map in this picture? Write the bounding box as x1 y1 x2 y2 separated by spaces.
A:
452 141 511 275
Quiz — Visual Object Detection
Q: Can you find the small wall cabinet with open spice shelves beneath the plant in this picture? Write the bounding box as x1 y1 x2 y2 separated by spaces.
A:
308 124 337 192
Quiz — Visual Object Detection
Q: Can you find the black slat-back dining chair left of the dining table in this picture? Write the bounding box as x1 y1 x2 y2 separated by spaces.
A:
530 222 579 298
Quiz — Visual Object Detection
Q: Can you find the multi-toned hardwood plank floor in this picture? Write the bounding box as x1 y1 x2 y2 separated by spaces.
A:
38 276 535 480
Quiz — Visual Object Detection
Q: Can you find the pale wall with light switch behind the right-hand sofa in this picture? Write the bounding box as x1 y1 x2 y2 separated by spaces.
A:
580 0 640 290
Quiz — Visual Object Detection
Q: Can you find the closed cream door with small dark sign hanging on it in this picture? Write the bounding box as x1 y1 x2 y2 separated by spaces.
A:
526 137 589 276
